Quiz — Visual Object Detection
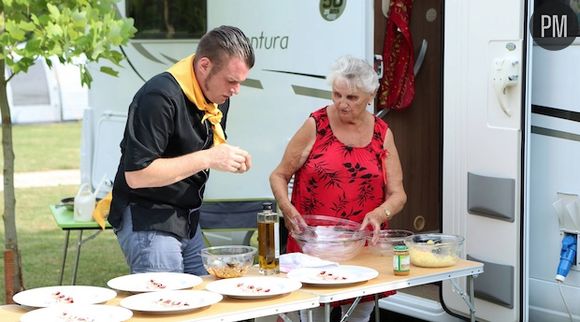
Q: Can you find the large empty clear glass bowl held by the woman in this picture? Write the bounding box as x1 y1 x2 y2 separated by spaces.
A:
291 215 367 262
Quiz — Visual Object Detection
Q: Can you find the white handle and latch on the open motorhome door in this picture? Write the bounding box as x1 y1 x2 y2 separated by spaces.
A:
492 57 520 116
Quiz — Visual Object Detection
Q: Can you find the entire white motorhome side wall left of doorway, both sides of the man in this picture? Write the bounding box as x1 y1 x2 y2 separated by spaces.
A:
83 0 373 199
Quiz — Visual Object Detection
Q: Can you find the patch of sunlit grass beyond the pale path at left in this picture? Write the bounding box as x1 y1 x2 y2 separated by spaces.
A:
0 121 81 172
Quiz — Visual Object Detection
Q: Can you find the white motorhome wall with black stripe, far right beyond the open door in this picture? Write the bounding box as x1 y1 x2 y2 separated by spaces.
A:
528 42 580 322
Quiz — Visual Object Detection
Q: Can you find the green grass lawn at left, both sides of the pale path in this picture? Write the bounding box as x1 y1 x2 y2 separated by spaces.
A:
0 122 128 303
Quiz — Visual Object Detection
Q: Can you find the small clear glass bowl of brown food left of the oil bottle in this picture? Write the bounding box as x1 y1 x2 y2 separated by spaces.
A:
201 245 257 278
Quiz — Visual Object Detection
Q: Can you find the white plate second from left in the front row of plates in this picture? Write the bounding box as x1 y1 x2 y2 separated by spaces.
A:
120 290 223 313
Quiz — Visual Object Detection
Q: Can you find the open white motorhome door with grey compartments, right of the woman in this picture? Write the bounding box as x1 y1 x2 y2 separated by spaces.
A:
442 0 524 321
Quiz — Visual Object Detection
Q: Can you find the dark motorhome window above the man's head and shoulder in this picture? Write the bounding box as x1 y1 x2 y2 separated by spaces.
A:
125 0 207 39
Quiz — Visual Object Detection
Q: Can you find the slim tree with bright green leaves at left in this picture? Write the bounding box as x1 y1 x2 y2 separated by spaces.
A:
0 0 136 303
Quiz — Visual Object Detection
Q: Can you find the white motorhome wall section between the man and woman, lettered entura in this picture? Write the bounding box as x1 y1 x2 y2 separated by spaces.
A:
206 0 372 199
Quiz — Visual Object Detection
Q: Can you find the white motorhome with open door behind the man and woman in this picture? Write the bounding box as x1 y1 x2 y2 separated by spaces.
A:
81 0 580 321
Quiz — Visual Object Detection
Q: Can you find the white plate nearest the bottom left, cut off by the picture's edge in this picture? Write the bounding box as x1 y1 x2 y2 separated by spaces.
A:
20 304 133 322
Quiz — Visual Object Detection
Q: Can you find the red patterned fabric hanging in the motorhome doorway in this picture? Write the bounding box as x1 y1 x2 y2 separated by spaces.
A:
378 0 415 110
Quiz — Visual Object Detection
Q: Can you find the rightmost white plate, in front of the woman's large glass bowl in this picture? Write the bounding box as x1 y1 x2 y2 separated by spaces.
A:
288 265 379 285
